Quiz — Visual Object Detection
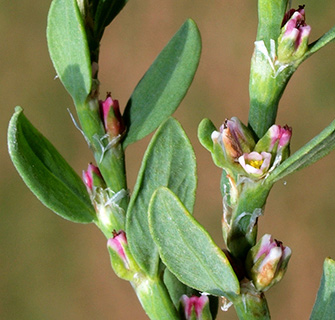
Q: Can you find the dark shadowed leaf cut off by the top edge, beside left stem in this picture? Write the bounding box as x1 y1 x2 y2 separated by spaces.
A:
94 0 128 40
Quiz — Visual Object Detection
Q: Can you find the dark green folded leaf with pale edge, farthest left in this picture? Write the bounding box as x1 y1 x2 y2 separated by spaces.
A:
8 107 95 223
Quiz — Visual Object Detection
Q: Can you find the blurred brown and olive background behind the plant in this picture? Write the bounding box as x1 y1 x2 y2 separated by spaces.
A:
0 0 335 320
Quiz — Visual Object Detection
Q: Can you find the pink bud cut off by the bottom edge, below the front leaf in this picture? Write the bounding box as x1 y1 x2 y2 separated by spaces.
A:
180 294 209 320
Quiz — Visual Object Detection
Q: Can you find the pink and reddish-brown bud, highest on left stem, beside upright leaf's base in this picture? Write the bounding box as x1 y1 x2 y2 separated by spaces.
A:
99 93 125 137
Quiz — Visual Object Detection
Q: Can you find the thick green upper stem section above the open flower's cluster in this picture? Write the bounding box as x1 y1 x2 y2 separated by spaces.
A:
249 0 293 139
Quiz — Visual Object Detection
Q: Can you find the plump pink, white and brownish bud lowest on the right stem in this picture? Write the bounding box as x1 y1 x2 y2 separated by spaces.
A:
246 234 291 291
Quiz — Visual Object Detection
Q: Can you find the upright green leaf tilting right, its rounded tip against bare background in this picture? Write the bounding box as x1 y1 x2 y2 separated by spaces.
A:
123 19 201 147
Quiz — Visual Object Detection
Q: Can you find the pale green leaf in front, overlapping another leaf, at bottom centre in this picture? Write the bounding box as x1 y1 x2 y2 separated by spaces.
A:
149 187 240 300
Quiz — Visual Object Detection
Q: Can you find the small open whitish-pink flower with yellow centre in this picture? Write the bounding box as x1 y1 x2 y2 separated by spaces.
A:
238 151 271 178
